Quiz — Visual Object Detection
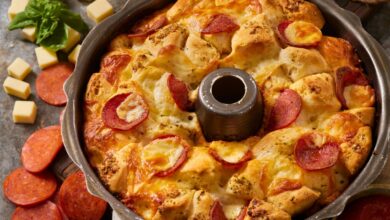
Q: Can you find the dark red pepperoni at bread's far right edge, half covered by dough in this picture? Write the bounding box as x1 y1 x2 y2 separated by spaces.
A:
336 66 369 109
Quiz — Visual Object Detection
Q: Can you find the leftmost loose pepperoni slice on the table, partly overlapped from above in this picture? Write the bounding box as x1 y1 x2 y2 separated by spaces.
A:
3 167 57 206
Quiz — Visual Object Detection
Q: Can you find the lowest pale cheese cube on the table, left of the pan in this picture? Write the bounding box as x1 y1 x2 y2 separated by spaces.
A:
12 101 38 124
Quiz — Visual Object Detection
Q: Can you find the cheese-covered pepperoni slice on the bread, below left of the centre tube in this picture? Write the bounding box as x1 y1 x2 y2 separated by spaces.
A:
142 135 190 177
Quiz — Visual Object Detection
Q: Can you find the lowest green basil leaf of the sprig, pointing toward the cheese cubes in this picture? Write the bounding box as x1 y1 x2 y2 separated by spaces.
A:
40 21 68 51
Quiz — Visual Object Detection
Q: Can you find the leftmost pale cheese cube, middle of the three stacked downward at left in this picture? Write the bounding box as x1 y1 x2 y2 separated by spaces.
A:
3 76 31 99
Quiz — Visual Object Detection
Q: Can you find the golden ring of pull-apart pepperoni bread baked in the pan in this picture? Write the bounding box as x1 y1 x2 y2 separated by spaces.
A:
84 0 375 220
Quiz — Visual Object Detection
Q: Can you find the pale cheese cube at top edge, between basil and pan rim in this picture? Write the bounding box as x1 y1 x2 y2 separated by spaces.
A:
87 0 114 23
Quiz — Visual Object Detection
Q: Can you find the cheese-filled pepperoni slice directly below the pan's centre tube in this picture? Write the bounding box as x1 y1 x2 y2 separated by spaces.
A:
209 142 252 169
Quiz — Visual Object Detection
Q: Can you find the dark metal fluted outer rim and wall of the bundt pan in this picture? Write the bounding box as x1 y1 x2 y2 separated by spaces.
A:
62 0 390 219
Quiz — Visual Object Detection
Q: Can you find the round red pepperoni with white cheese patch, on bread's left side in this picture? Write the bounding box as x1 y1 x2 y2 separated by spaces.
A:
102 92 149 131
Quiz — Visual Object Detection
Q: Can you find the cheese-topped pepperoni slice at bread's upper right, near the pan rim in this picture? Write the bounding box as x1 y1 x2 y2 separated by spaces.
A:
278 21 322 47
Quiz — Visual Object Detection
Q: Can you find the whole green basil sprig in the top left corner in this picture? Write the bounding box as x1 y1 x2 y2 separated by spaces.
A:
8 0 89 51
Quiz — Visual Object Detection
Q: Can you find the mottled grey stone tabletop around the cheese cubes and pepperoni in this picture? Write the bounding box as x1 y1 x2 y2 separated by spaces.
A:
0 0 390 219
